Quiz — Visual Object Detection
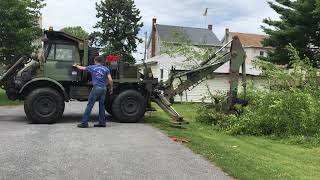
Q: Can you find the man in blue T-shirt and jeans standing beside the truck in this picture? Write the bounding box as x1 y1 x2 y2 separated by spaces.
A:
74 56 113 128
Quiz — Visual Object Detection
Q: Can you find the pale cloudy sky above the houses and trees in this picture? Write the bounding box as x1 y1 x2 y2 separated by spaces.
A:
42 0 278 58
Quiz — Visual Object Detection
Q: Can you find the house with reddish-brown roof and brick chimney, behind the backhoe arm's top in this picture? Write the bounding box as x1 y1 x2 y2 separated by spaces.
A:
222 29 273 64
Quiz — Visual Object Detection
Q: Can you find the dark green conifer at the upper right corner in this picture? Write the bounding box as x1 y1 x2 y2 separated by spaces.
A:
262 0 320 66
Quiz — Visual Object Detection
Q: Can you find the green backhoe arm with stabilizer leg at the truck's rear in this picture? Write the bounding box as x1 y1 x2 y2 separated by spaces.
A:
153 36 246 124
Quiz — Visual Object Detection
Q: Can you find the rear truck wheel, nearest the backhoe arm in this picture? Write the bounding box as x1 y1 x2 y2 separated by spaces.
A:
112 90 146 123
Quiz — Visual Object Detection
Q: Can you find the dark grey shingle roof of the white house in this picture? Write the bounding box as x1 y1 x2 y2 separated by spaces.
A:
156 24 221 46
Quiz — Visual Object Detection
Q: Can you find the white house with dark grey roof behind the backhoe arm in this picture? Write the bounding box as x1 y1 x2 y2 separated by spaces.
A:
146 19 263 102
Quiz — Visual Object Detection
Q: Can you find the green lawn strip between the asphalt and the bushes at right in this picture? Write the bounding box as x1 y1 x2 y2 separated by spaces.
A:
145 104 320 180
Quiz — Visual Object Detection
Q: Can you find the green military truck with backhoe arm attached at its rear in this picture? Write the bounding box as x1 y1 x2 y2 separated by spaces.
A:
0 30 245 125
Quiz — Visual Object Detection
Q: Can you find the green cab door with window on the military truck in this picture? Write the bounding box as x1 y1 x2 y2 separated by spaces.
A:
44 44 81 81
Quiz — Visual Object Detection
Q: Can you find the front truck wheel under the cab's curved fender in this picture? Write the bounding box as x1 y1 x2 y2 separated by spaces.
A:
24 88 65 124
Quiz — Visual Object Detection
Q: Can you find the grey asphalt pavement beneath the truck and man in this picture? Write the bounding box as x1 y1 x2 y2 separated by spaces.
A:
0 103 230 180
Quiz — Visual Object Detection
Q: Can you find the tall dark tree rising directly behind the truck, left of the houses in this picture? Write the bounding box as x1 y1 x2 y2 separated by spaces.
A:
91 0 143 63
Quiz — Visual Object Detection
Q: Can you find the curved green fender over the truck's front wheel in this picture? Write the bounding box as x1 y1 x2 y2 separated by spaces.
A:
19 78 69 101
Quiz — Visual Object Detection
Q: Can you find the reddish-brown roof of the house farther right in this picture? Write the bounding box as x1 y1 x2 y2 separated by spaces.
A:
230 32 268 47
